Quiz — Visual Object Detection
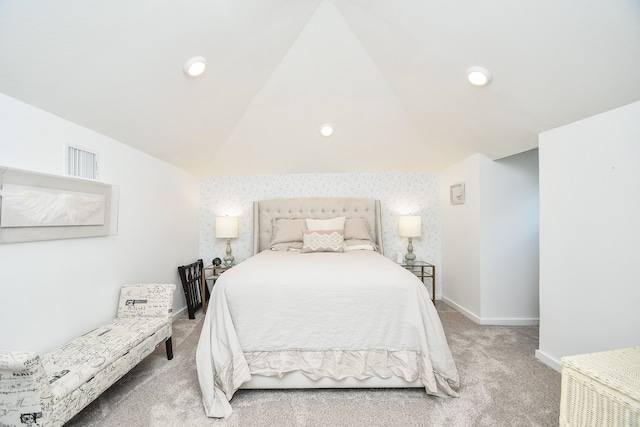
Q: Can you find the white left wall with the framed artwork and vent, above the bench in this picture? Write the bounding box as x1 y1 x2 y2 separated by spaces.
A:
0 94 199 358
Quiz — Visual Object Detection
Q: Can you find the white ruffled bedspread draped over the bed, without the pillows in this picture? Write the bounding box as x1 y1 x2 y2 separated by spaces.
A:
196 251 459 417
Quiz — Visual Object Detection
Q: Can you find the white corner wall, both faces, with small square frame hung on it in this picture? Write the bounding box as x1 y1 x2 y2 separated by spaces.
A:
441 150 538 325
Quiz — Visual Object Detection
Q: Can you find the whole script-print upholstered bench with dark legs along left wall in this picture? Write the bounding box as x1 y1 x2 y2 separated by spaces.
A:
0 284 176 426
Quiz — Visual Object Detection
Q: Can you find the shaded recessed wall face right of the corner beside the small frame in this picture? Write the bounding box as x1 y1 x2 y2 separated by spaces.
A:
480 150 540 324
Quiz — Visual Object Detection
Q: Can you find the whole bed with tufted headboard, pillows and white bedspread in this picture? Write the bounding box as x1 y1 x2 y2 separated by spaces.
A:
196 198 459 417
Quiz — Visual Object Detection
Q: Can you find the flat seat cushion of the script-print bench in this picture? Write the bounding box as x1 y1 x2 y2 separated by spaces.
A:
42 317 170 404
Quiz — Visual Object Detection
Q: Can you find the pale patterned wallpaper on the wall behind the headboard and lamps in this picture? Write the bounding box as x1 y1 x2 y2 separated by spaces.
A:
200 173 441 284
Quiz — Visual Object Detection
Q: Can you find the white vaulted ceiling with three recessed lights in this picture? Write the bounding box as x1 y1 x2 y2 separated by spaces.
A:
0 0 640 178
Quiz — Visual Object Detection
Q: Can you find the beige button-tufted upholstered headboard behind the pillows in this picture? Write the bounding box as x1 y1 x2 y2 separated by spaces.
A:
253 197 384 255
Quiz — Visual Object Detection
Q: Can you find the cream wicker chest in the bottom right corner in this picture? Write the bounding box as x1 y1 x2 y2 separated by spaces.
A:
560 347 640 427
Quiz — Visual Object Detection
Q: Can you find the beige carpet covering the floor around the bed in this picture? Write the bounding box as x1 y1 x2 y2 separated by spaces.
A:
67 302 560 427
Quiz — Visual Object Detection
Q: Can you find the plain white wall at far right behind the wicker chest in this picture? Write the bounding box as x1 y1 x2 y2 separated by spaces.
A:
536 102 640 369
